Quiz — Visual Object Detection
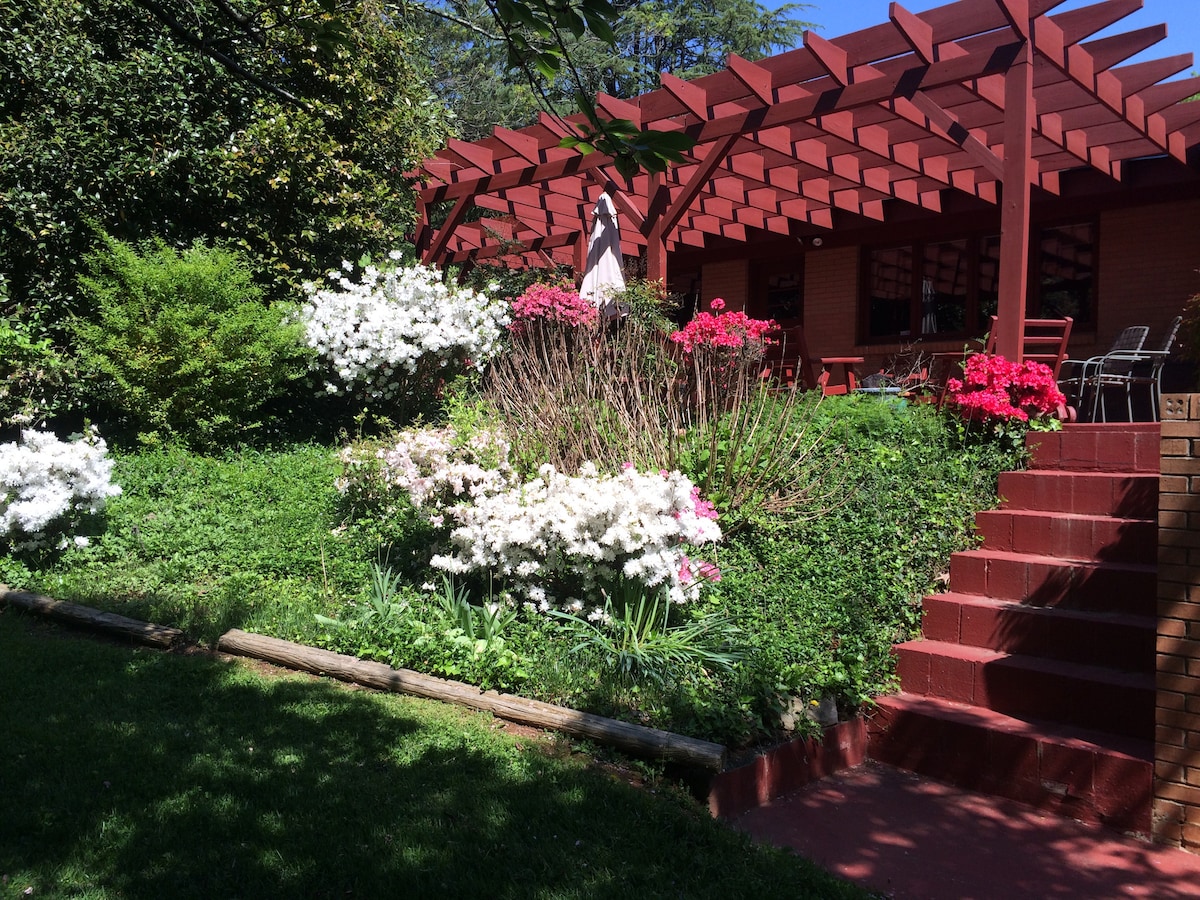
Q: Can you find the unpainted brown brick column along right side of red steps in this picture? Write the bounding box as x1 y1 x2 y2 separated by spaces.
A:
1153 394 1200 853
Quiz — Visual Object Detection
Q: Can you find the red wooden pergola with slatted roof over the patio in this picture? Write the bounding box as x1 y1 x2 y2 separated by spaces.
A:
413 0 1200 359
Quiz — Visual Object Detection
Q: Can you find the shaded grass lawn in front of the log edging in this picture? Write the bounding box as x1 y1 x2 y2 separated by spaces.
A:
0 611 863 899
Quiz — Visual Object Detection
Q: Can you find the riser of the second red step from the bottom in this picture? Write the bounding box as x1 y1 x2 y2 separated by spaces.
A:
894 643 1154 740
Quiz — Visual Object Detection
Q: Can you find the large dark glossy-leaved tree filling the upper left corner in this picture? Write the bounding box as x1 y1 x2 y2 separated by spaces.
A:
0 0 446 321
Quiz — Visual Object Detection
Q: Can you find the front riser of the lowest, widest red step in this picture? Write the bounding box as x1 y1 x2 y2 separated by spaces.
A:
868 697 1153 833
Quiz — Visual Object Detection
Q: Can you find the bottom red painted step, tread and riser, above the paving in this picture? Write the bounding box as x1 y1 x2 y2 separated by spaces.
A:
868 694 1153 833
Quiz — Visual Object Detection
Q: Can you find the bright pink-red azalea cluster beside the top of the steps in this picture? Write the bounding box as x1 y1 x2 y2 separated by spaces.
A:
946 353 1067 422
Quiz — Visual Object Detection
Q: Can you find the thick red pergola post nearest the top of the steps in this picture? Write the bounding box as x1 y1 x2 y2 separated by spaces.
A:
996 41 1034 362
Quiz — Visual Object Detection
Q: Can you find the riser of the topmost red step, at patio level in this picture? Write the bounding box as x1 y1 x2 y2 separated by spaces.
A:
1026 422 1160 474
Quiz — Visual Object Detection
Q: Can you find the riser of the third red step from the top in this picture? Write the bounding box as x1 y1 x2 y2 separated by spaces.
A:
976 510 1158 564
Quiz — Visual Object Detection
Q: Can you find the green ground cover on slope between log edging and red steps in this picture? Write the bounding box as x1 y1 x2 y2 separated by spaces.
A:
0 398 1015 748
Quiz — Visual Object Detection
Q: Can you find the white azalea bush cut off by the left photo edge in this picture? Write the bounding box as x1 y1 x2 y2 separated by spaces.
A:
0 428 121 550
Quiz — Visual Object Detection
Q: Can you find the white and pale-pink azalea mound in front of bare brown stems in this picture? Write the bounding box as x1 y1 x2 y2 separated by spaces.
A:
337 427 721 612
